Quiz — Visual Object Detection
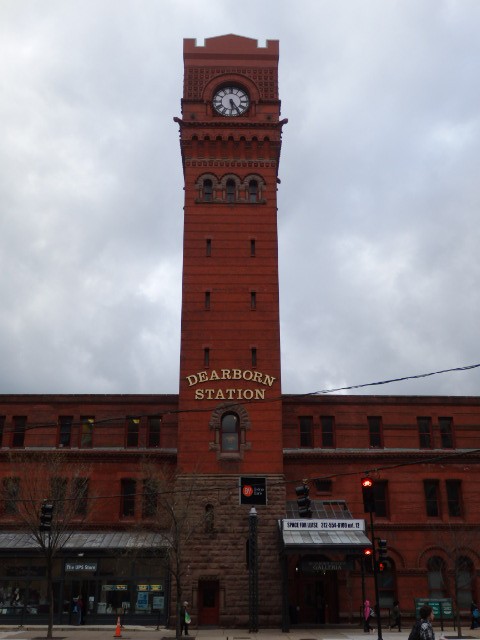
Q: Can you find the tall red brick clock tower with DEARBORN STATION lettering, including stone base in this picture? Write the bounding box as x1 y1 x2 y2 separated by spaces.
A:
176 35 285 624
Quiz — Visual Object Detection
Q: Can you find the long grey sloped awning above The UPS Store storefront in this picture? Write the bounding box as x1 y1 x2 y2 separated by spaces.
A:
0 531 168 551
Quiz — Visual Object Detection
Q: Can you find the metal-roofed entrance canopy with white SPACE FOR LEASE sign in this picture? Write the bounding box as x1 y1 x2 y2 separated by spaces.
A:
278 501 372 553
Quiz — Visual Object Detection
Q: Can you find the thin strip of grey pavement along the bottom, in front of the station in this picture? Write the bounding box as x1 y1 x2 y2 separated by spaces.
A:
0 625 480 640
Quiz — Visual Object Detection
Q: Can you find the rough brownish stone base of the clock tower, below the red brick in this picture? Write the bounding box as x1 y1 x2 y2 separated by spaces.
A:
171 474 285 628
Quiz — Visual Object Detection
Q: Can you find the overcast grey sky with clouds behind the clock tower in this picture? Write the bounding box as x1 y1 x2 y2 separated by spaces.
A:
0 0 480 395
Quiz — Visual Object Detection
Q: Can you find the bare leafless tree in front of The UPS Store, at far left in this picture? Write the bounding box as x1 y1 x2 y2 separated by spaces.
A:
1 451 90 638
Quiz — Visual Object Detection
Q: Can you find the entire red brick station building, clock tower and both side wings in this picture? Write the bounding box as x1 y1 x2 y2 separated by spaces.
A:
0 35 480 629
